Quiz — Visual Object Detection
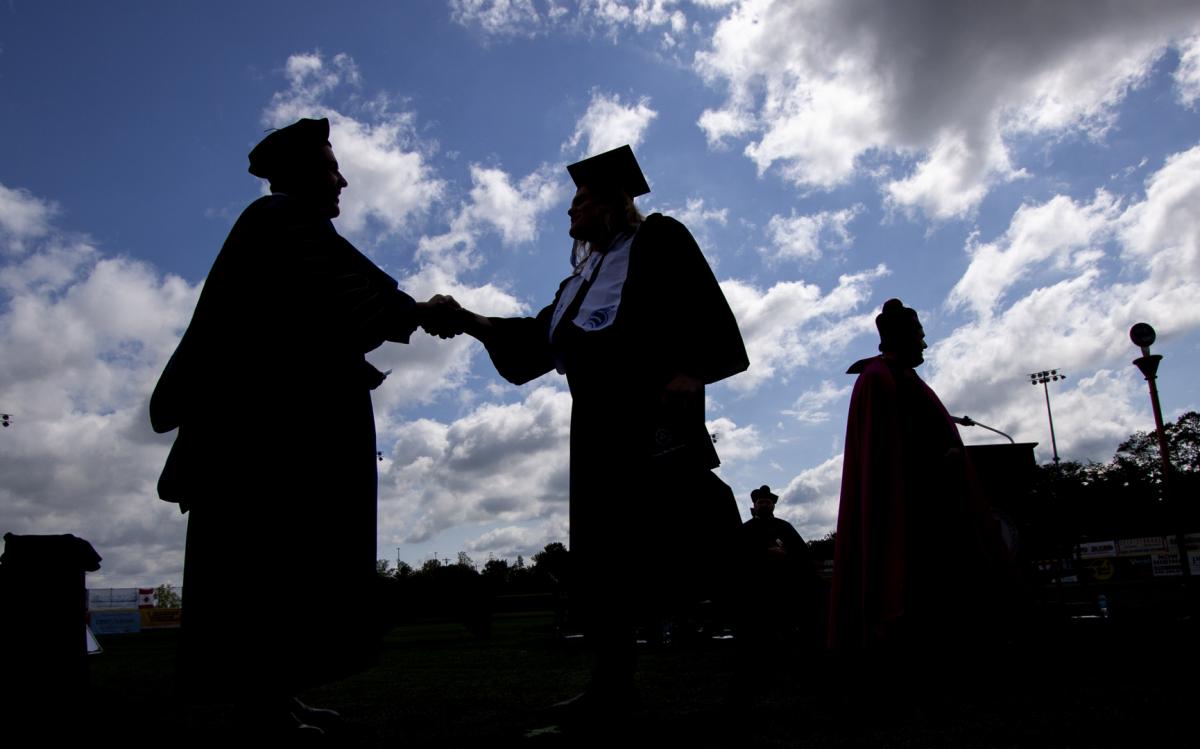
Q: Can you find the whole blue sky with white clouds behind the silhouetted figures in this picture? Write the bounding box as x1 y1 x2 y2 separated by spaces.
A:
0 0 1200 586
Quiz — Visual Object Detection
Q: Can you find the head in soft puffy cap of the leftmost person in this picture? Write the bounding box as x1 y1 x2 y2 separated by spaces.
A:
250 119 349 218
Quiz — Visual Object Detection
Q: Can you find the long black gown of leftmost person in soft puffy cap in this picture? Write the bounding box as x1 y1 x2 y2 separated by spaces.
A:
150 194 416 701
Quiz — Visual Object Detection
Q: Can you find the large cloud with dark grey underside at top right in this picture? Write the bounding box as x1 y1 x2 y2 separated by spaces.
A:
695 0 1200 218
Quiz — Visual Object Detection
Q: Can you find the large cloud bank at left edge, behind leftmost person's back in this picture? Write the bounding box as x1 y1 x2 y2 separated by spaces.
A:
0 180 199 587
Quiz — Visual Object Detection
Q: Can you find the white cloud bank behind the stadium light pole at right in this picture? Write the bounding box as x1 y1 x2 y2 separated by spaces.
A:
926 146 1200 460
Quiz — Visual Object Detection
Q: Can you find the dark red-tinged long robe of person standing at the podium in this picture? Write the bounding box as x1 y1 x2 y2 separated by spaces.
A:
829 356 988 652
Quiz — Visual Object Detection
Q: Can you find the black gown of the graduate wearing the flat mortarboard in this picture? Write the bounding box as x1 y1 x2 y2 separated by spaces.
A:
486 214 749 616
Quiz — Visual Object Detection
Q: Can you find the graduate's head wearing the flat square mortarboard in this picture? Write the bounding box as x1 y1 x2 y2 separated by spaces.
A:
566 145 650 262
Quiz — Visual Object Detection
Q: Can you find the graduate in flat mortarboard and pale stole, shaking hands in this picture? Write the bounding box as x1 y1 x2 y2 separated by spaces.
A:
444 146 749 714
